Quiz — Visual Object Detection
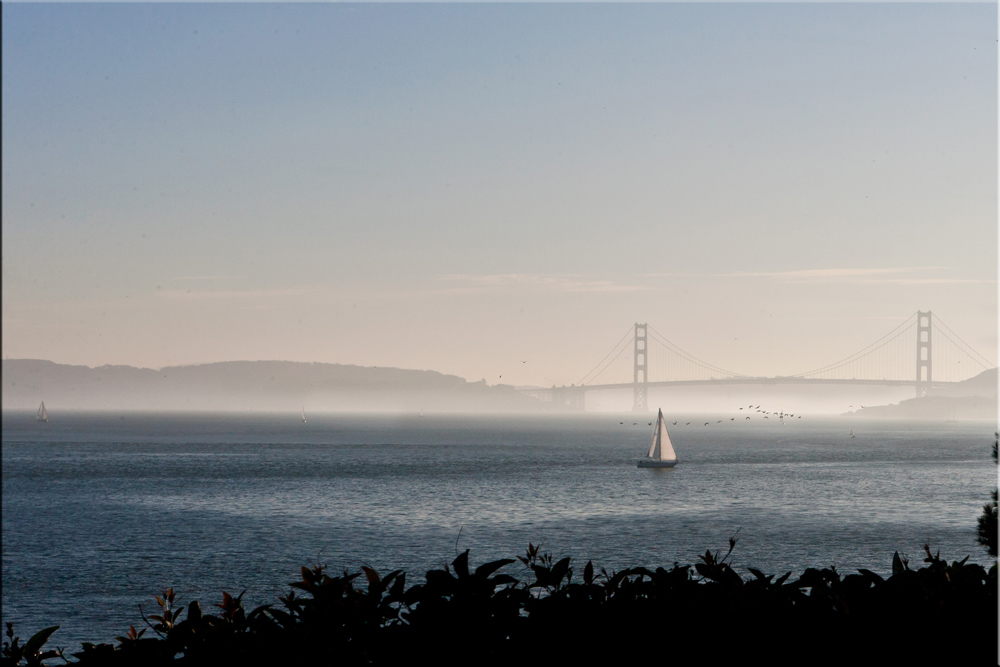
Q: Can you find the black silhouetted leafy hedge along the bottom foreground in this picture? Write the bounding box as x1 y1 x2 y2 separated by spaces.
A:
0 537 997 667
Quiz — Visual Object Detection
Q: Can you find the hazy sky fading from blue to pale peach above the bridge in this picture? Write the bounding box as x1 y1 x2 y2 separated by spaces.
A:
2 3 998 385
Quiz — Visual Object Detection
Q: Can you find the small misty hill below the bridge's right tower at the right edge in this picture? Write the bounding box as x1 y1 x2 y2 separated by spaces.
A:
849 368 998 421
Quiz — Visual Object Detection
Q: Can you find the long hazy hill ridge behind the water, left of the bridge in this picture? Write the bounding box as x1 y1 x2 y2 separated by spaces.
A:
2 359 543 412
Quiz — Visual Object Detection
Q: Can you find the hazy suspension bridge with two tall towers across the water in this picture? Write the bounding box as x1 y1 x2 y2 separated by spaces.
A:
527 311 996 412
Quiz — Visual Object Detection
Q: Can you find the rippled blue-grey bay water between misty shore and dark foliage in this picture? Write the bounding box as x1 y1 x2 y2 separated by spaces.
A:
2 413 997 650
